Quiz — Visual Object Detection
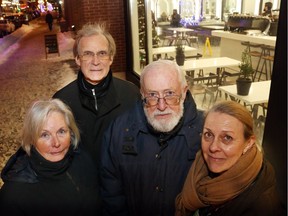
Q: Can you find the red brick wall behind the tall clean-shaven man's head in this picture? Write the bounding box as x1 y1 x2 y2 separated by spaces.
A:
64 0 126 72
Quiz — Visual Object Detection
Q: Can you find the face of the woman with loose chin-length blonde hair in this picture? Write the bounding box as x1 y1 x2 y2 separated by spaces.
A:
35 112 71 162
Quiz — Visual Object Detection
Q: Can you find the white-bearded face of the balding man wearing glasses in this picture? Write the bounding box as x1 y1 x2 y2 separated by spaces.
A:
142 66 186 132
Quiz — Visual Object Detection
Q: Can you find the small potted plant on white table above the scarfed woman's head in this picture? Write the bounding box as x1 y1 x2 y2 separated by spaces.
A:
236 48 254 95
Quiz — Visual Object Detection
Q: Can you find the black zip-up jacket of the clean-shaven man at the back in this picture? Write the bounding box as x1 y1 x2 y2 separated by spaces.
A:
53 71 140 165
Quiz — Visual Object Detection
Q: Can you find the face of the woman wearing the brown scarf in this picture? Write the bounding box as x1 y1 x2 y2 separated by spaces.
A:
202 112 255 173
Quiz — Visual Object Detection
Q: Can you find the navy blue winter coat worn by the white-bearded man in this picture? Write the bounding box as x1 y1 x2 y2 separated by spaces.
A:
101 92 203 216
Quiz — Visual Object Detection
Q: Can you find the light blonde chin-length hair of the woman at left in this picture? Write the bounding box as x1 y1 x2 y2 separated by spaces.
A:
21 99 80 155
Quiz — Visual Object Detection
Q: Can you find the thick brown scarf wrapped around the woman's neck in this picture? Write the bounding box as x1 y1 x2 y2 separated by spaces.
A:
175 145 263 216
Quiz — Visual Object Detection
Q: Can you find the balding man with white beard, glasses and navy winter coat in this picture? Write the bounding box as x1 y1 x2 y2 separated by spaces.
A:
100 60 203 216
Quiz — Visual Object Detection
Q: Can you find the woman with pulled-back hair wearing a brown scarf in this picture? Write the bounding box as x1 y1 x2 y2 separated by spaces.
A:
175 101 284 216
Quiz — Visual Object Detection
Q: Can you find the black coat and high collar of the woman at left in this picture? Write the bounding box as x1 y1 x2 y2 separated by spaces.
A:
0 147 101 216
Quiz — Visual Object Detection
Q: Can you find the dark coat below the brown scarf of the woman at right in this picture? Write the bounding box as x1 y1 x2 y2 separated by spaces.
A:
199 160 286 216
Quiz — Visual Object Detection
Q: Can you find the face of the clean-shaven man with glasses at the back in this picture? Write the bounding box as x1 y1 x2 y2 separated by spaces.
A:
75 35 113 85
